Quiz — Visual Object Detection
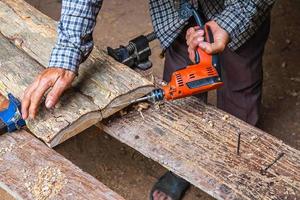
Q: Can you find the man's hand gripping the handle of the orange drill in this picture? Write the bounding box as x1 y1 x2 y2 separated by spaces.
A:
186 21 229 62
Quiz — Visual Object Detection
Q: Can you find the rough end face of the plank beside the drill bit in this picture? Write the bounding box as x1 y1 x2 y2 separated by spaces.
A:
99 85 154 118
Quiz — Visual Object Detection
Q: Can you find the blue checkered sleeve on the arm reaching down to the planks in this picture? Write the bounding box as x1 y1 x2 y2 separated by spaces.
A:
49 0 102 74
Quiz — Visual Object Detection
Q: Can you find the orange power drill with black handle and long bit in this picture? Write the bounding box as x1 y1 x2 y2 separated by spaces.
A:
115 4 223 107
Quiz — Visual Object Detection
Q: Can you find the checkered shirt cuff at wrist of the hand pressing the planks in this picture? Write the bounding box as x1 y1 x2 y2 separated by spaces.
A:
48 45 82 75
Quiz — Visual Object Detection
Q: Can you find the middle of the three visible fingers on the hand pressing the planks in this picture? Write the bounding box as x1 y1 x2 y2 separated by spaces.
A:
29 80 51 119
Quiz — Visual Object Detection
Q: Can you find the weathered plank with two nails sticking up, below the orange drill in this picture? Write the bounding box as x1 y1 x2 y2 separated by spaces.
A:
99 98 300 200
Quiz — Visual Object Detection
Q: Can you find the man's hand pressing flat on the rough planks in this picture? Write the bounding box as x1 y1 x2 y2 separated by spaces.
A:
22 68 75 119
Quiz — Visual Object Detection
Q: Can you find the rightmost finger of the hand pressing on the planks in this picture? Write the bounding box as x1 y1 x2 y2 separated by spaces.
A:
46 79 69 109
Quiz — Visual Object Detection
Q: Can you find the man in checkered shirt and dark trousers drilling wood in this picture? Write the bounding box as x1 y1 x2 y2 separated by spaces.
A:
22 0 275 200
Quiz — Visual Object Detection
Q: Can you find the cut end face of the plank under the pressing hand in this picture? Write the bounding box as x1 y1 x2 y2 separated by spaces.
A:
46 111 102 148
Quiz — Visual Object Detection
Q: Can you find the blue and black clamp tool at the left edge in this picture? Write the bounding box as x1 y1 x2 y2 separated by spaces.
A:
0 94 26 133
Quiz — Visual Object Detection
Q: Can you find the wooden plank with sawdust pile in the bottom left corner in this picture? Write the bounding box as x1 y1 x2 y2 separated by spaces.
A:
0 131 123 200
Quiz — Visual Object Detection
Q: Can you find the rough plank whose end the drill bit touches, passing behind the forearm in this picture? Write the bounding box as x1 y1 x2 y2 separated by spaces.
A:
0 0 153 118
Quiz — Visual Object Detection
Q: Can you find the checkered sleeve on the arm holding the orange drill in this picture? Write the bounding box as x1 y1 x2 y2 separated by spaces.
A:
214 0 275 46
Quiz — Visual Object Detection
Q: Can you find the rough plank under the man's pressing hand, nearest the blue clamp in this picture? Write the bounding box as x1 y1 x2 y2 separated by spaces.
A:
0 34 102 147
